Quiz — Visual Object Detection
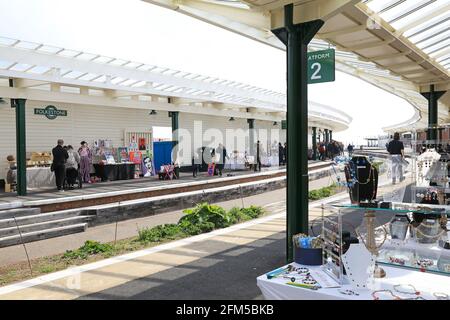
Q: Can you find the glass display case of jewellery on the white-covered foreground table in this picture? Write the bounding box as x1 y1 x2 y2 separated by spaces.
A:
325 203 450 276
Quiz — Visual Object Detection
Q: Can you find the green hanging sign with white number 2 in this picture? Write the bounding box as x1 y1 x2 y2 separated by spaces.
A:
308 49 335 84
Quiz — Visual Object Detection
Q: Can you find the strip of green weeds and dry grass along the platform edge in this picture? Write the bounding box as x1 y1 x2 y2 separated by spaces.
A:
0 203 265 285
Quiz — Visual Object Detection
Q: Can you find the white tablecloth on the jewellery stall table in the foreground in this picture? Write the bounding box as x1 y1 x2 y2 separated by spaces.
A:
257 263 450 300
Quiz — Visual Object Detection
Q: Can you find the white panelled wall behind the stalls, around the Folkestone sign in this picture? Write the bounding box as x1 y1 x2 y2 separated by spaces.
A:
0 102 171 179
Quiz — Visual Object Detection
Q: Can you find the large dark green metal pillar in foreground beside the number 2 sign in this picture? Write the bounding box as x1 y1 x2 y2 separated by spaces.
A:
272 4 324 262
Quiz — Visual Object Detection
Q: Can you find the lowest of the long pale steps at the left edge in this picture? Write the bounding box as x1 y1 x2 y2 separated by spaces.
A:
0 223 87 248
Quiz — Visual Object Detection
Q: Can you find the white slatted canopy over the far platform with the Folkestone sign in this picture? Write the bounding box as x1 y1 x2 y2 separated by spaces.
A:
0 37 352 131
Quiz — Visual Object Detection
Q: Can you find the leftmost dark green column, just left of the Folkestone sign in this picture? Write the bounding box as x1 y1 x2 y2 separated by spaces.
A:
14 99 27 196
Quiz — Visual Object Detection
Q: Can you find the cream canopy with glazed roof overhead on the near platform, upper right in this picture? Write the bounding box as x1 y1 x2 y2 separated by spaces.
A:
143 0 450 131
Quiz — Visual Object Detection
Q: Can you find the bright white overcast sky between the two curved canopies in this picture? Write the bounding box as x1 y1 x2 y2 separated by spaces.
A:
0 0 413 143
